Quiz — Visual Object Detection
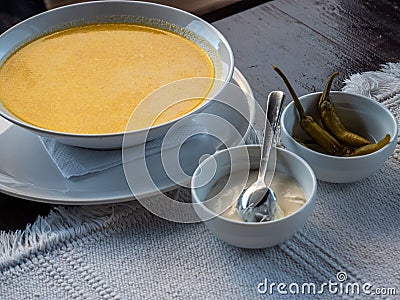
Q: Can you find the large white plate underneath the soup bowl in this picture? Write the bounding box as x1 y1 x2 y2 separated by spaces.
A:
0 69 255 205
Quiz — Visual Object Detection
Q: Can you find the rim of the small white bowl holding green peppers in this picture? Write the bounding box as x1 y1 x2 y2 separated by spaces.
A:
280 91 398 161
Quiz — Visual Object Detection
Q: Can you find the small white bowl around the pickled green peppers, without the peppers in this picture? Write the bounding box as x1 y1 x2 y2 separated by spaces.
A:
281 92 398 183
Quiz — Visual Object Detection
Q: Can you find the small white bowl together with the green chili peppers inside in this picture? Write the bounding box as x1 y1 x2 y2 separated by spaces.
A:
274 67 398 183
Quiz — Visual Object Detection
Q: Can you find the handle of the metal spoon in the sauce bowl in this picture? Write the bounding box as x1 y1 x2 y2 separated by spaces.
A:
258 91 285 182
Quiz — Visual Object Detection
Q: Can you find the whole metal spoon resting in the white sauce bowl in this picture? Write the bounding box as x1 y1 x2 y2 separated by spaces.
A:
237 91 285 222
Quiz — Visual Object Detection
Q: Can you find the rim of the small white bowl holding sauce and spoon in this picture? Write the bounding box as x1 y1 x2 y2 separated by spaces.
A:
190 145 317 227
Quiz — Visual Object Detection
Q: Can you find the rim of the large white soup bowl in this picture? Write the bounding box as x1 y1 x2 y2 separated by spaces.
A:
0 0 235 139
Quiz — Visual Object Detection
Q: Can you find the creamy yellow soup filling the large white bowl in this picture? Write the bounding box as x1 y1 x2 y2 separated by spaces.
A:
0 24 214 134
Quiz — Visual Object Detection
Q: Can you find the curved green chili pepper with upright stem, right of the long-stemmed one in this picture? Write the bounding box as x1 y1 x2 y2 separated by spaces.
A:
318 72 370 148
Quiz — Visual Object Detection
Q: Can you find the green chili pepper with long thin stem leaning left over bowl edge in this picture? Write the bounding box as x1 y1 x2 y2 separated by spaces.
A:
272 66 350 155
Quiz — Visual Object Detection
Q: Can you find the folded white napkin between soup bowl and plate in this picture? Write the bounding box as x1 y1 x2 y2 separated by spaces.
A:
40 125 207 179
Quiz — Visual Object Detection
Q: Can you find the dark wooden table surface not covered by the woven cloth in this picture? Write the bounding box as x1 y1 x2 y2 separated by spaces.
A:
0 0 400 230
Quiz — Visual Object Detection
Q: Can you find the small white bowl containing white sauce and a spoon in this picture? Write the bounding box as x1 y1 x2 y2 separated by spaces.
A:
192 145 317 248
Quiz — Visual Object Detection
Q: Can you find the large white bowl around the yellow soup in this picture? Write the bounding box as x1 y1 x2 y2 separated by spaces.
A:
0 1 234 149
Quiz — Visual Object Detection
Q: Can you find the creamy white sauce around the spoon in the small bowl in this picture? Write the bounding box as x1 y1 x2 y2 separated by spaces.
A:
205 170 306 221
